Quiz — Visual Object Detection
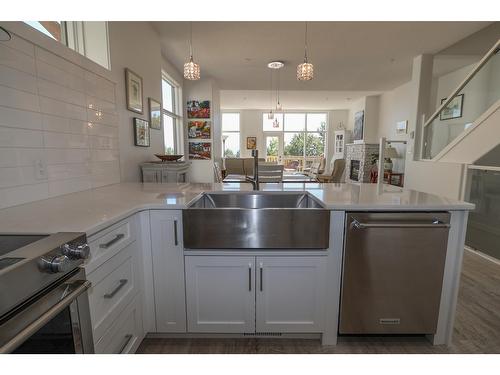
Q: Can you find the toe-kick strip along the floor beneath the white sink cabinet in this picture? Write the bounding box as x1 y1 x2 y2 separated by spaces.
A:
146 332 321 340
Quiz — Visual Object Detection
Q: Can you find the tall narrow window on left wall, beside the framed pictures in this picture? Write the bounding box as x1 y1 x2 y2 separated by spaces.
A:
161 73 183 155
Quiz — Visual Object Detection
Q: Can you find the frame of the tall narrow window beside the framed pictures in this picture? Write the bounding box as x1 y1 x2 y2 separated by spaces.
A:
161 71 184 155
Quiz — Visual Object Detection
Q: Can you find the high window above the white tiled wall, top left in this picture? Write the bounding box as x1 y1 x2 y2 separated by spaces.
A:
25 21 111 69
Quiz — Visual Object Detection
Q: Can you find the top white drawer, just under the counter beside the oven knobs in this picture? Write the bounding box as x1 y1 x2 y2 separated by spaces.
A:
85 216 136 274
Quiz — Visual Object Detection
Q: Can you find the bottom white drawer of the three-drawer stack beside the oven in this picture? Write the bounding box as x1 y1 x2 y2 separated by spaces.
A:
95 296 144 354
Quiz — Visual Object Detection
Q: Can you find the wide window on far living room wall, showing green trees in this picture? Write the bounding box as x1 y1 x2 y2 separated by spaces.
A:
262 113 328 171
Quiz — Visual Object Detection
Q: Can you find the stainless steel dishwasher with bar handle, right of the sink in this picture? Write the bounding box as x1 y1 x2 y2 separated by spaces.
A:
339 212 450 334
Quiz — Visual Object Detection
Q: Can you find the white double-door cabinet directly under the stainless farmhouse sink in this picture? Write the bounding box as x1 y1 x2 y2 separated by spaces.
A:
186 255 326 333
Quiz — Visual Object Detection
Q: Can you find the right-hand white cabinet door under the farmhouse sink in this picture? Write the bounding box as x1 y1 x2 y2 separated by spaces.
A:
256 256 326 333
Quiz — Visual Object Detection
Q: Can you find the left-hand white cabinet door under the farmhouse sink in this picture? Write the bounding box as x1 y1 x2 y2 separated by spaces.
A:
186 256 255 333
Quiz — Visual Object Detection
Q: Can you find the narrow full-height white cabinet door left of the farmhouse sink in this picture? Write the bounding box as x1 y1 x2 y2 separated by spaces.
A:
151 210 186 332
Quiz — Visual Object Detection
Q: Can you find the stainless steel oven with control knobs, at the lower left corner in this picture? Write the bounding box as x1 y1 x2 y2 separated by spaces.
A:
0 233 94 354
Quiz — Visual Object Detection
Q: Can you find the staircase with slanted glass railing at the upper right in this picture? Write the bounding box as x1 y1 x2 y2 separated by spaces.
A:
423 40 500 164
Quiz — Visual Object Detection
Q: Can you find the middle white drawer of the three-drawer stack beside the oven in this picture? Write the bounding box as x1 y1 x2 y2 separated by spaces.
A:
88 242 139 341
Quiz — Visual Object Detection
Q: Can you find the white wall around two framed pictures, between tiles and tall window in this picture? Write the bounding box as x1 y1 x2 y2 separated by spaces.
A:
108 22 182 182
